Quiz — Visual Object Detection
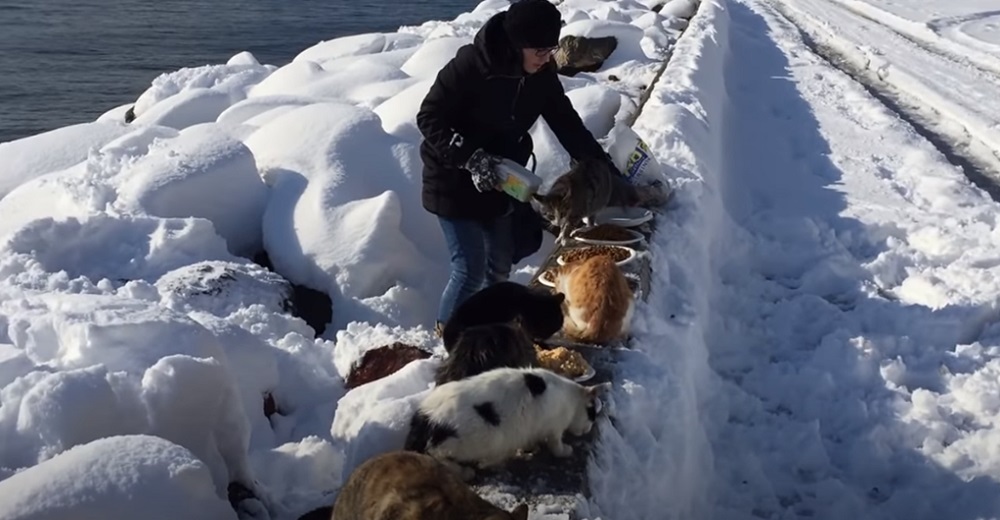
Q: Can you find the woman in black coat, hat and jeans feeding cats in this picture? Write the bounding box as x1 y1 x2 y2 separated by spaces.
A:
417 0 607 330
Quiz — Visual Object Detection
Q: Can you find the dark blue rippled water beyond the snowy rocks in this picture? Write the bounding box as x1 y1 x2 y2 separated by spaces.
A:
0 0 479 142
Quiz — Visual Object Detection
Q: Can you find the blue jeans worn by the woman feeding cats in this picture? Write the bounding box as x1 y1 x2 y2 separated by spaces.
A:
437 212 514 323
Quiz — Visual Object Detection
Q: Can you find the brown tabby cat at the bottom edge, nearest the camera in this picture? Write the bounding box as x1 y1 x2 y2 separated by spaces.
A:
330 451 528 520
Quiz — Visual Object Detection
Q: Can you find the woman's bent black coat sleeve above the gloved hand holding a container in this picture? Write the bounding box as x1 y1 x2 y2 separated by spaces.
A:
417 45 482 167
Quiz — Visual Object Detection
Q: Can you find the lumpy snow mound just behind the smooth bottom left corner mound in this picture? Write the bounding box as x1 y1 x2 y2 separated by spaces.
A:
0 293 250 496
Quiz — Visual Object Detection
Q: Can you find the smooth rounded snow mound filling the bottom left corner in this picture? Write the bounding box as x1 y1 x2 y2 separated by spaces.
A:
0 435 236 520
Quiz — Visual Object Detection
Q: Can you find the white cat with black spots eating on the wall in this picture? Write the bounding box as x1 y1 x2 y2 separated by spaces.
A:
405 368 610 478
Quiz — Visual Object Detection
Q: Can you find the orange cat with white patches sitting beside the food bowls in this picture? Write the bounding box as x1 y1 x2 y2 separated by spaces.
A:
555 256 634 343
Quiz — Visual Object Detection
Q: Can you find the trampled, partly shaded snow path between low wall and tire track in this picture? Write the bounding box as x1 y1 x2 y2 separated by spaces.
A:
709 2 1000 518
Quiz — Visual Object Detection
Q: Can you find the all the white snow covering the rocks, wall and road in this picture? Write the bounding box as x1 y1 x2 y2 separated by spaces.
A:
0 0 1000 520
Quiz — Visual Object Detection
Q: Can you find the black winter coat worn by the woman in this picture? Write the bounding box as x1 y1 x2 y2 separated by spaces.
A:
417 11 606 221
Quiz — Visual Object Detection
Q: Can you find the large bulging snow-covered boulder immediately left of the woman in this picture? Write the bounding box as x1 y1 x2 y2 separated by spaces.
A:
247 103 442 316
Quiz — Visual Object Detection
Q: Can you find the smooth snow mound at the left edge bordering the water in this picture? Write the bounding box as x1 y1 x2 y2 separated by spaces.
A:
0 122 132 200
